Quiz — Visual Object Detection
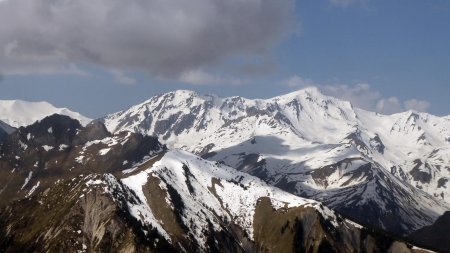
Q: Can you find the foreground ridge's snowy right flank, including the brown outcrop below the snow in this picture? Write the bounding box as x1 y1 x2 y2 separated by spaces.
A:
118 150 428 252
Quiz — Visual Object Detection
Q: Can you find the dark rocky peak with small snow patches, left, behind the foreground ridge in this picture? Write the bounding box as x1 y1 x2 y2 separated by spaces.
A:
0 115 165 206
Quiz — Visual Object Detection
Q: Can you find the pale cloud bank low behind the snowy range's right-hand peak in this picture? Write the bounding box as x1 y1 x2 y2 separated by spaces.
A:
281 75 430 114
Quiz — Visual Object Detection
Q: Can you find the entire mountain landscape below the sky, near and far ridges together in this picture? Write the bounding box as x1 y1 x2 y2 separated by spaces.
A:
0 88 450 252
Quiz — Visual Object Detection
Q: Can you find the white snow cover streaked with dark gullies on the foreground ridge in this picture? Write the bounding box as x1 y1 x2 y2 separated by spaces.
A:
122 150 332 245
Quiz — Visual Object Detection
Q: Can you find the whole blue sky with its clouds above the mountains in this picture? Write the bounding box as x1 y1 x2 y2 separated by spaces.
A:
0 0 450 118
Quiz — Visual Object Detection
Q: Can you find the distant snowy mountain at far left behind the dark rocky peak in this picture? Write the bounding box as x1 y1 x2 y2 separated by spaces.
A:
0 100 91 128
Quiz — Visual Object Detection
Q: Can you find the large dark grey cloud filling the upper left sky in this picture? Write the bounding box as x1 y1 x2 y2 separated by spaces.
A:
0 0 294 77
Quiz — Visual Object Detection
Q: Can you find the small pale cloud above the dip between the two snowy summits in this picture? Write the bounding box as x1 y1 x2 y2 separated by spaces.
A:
179 69 246 85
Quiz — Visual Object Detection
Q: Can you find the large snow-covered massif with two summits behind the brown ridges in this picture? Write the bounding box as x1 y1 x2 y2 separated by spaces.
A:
104 88 450 234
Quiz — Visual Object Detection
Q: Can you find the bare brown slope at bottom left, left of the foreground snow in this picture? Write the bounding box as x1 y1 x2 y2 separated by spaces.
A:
0 174 175 252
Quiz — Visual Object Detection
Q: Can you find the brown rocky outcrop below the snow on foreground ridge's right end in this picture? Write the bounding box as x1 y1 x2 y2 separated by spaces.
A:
254 198 400 253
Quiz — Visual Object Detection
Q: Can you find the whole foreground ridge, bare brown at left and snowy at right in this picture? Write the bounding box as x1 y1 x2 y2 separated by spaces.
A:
0 151 428 252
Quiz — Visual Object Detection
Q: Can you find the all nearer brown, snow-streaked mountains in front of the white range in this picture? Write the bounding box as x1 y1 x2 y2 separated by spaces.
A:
0 115 426 252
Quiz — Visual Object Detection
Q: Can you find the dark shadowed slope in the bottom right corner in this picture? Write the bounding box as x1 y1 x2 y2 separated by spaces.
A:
409 212 450 253
